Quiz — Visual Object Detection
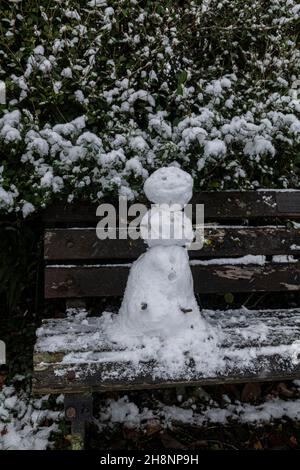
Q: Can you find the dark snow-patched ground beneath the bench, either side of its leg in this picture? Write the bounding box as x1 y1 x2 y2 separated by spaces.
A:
0 376 300 451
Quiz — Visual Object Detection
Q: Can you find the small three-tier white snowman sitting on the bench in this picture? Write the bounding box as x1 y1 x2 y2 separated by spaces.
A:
119 167 211 337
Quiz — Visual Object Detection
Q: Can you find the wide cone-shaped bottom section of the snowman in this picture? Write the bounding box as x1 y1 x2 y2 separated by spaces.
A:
116 246 213 340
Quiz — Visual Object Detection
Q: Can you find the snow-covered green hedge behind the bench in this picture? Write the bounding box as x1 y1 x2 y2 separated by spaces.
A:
0 0 300 215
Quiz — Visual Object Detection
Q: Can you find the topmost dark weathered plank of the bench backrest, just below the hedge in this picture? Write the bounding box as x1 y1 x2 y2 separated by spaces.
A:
44 190 300 226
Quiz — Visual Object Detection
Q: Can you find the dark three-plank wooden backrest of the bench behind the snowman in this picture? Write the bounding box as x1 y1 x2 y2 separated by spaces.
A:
44 190 300 299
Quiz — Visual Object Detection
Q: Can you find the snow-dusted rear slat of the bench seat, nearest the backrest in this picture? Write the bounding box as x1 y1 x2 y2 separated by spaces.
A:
34 309 300 356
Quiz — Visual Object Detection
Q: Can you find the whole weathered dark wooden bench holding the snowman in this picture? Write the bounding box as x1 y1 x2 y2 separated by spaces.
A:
33 191 300 447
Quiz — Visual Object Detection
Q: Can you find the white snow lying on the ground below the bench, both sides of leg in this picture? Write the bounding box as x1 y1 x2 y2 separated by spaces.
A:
0 377 300 450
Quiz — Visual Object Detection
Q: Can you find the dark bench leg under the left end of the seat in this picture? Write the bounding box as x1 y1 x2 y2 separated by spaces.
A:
65 394 93 450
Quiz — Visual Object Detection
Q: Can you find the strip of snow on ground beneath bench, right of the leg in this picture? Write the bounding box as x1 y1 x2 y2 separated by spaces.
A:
99 383 300 430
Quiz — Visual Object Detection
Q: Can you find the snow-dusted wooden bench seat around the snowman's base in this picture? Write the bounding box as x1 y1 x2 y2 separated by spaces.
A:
33 309 300 394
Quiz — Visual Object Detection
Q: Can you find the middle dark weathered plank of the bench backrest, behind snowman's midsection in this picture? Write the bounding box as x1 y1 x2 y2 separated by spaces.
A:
44 226 300 261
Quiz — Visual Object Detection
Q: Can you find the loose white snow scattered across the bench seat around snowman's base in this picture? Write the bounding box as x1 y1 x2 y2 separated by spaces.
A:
36 304 300 390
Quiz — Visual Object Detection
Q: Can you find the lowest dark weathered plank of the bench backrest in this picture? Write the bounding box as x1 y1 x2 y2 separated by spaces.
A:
45 261 300 299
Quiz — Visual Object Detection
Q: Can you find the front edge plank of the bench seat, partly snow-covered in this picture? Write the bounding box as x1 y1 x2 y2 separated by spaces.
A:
33 355 300 394
